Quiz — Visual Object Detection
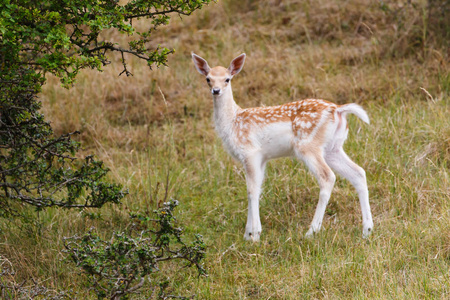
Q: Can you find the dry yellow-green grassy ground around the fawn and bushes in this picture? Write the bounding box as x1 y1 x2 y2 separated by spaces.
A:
0 0 450 299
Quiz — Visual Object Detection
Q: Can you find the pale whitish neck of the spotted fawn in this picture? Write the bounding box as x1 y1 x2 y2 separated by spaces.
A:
213 84 241 144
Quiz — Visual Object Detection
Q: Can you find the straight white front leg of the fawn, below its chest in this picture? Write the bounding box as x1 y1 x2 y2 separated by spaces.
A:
244 155 265 242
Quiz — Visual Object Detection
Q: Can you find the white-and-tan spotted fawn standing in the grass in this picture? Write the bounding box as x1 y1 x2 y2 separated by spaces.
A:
191 52 373 242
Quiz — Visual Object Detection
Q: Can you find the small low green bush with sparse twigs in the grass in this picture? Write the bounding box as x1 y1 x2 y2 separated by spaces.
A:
65 200 206 299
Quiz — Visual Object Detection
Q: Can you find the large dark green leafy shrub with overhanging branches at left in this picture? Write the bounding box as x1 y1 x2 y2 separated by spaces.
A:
0 0 210 216
